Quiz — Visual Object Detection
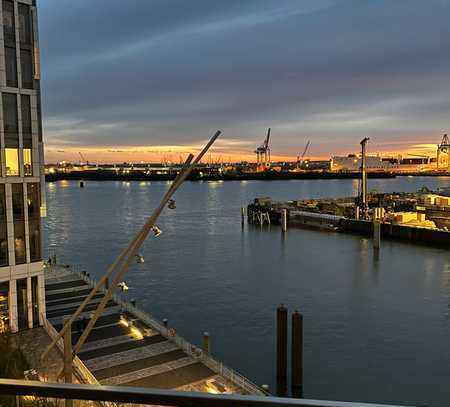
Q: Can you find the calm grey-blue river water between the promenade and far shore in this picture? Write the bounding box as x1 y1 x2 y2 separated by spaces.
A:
44 177 450 406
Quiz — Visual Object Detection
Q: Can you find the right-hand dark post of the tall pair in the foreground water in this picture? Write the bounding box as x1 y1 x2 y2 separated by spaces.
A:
291 311 303 398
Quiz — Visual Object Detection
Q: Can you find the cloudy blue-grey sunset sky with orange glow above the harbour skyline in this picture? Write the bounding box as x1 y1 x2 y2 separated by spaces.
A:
38 0 450 162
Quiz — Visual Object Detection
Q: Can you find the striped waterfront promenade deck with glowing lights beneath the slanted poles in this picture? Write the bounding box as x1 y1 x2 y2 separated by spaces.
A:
45 266 265 395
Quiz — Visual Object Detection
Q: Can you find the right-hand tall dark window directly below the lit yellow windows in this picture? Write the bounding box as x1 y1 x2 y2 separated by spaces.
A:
27 184 42 262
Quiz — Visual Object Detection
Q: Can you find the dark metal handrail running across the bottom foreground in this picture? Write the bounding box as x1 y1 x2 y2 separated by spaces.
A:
0 379 414 407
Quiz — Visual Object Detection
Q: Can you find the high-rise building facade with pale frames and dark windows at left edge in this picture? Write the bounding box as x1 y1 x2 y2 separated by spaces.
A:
0 0 45 332
